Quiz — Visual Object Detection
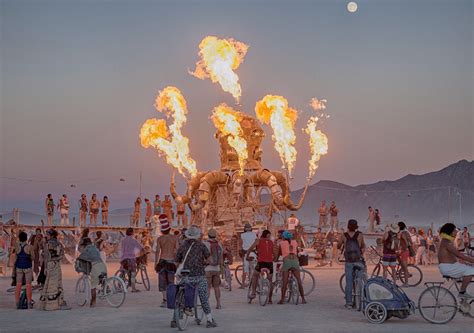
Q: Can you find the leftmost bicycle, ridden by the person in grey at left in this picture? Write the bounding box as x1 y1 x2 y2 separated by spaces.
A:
76 274 127 308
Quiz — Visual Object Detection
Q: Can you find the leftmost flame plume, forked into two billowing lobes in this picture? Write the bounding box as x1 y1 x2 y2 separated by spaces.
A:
140 86 197 177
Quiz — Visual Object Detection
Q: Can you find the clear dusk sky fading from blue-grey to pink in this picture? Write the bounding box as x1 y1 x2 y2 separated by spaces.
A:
0 0 474 211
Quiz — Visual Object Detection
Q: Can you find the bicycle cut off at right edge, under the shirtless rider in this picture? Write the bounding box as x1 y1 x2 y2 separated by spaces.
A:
418 276 474 324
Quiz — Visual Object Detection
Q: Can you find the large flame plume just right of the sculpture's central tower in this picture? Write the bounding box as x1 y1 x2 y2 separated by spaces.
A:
255 95 298 175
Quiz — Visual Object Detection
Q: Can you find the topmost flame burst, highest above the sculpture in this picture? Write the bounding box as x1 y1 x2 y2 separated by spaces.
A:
190 36 248 102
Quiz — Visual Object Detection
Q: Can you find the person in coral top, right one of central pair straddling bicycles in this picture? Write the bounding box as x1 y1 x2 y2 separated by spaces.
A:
275 230 306 304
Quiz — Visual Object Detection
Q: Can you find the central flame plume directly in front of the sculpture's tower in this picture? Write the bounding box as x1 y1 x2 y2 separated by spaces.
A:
211 103 248 175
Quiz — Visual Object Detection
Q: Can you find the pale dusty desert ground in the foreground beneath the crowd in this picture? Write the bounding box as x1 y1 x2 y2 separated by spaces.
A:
0 262 474 333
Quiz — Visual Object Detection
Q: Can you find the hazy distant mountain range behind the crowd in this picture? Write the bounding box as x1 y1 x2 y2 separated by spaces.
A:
3 160 474 226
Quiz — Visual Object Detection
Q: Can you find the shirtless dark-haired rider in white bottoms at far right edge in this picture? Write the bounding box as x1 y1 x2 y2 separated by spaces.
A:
438 223 474 299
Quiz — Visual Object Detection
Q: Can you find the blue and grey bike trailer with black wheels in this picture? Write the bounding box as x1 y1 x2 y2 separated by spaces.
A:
362 277 415 324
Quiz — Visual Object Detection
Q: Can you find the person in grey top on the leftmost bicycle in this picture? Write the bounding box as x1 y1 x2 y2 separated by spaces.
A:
77 238 107 308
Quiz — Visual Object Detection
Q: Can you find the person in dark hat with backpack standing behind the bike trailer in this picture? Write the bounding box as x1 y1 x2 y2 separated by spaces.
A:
337 219 365 309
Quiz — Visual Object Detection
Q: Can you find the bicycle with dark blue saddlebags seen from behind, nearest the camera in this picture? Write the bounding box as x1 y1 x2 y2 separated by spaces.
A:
173 269 204 331
